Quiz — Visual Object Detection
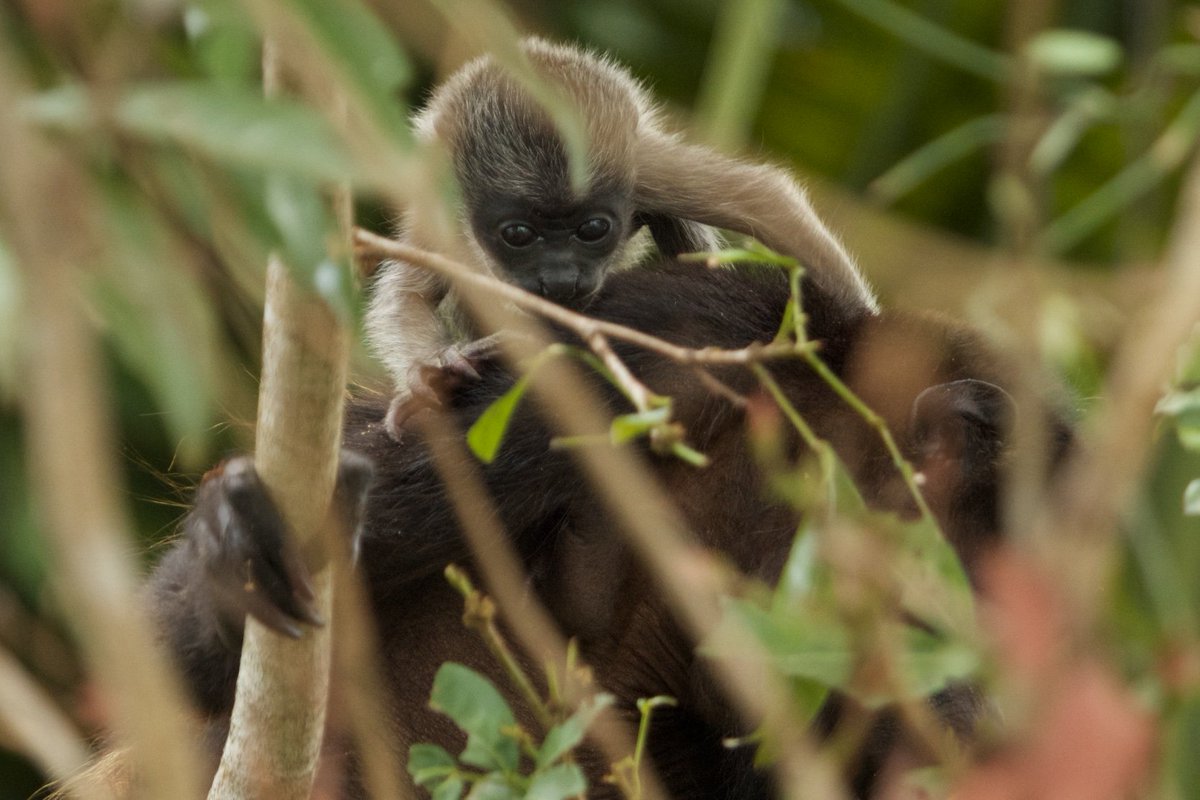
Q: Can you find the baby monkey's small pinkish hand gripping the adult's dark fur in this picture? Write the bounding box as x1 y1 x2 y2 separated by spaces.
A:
384 332 508 441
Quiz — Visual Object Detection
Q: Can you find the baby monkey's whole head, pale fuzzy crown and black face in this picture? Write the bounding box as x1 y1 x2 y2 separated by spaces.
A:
415 38 676 308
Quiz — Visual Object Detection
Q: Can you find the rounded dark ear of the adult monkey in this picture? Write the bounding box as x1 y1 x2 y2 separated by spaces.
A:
908 379 1016 528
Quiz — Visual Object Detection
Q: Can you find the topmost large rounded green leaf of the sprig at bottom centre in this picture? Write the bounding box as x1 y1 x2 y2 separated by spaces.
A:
430 662 518 772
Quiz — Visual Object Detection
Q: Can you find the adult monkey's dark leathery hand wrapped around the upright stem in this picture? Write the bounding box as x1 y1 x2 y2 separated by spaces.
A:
180 450 373 638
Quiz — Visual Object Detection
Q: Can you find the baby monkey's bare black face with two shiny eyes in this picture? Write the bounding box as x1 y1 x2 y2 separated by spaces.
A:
470 191 634 308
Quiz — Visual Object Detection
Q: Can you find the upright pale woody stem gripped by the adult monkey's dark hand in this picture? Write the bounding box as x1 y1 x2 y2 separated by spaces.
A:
209 46 348 800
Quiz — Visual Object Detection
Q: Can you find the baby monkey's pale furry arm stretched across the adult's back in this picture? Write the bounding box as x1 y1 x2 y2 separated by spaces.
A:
636 133 877 312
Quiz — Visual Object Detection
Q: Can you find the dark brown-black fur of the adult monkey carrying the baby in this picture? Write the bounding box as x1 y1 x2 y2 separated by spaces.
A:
152 263 1060 799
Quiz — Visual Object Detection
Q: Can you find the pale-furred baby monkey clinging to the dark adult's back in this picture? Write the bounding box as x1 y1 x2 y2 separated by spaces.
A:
367 38 876 438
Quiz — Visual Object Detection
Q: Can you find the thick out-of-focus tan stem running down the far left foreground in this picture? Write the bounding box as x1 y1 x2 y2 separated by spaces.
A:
0 51 200 799
